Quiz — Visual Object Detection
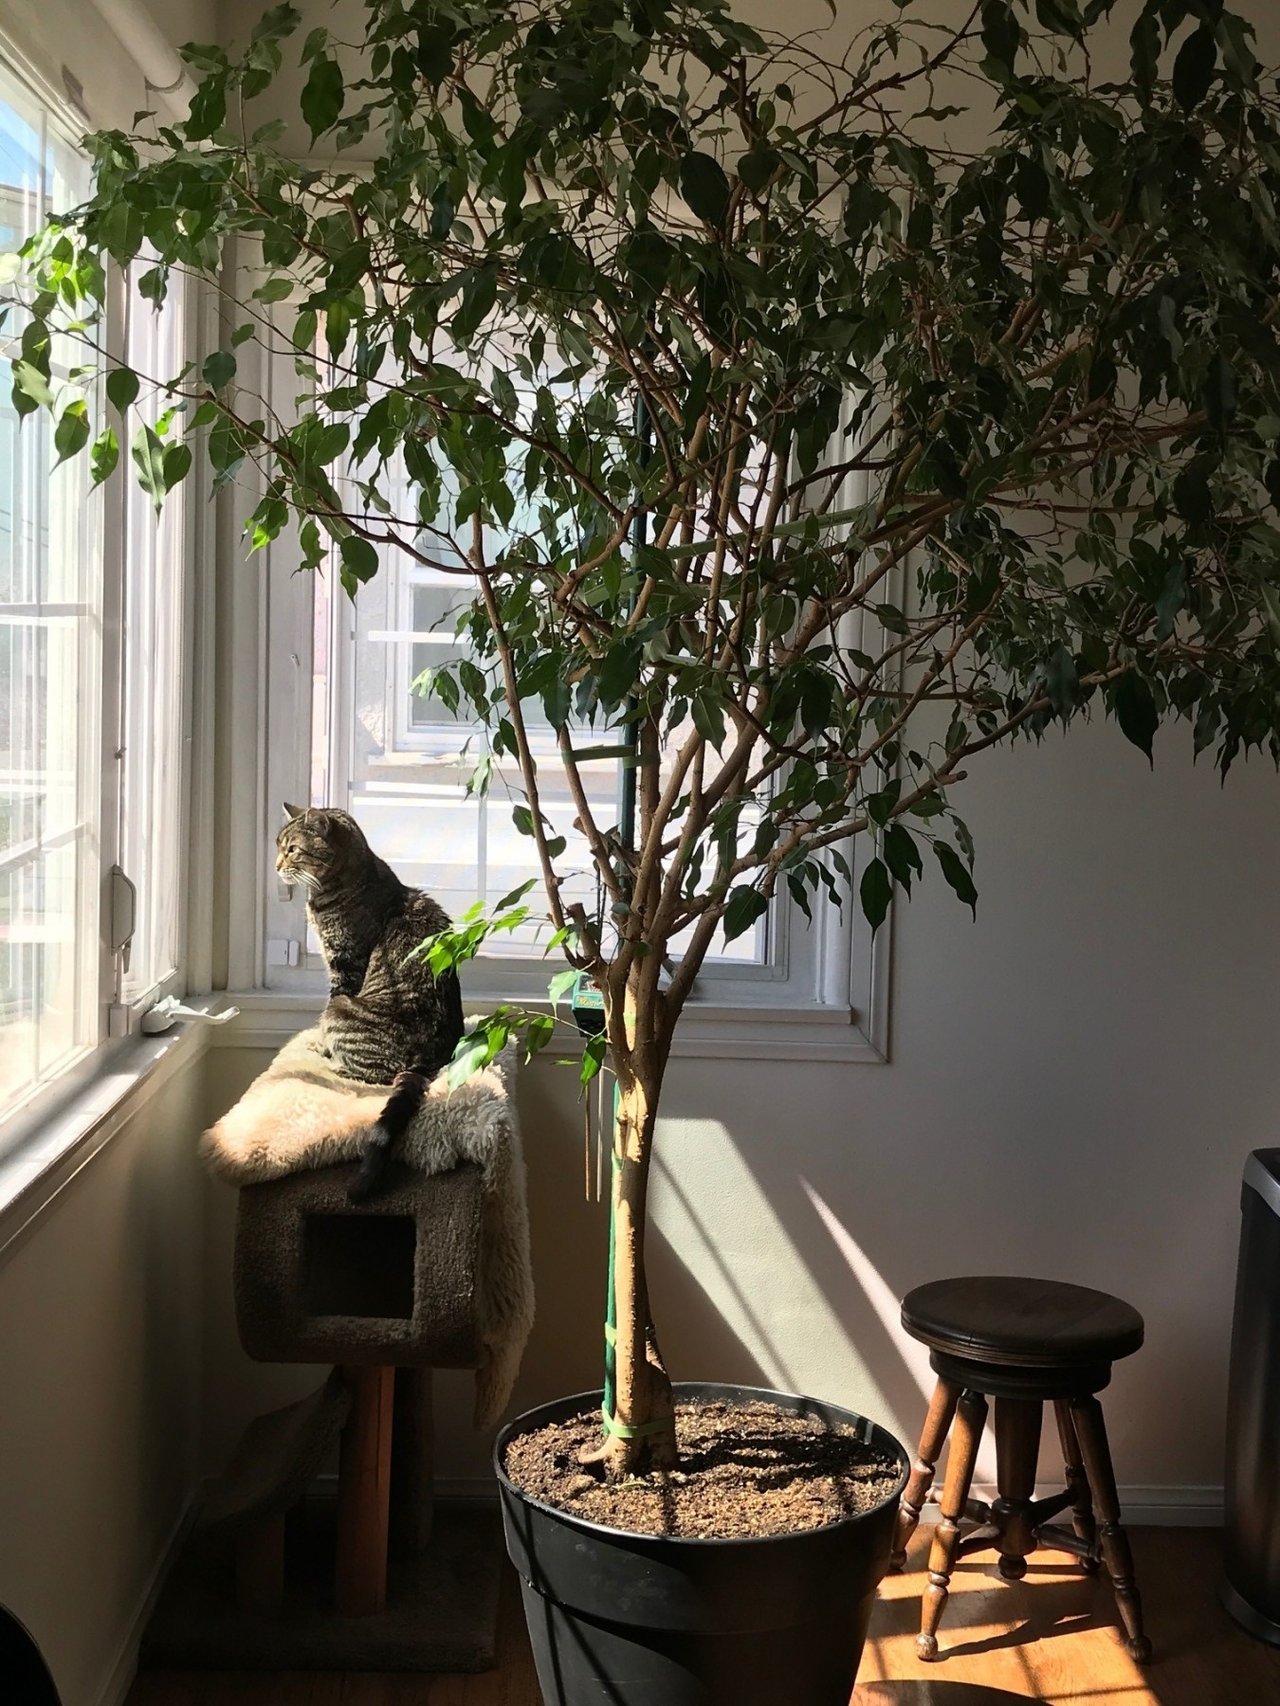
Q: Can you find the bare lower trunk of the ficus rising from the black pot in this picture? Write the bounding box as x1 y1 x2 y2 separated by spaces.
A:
599 1009 676 1481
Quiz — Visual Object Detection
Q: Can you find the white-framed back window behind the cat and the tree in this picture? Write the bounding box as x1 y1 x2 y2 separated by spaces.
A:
247 322 889 1061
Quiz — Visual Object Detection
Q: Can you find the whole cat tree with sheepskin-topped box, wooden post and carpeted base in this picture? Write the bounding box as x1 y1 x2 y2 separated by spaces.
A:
143 1030 532 1670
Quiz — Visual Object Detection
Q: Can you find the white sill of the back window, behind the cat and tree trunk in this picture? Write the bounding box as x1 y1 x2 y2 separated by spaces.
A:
210 989 887 1065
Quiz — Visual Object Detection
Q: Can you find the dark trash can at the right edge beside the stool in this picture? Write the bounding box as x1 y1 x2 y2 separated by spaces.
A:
1222 1150 1280 1645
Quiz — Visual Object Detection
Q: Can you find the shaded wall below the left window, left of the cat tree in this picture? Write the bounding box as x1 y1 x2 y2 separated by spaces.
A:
0 1051 203 1706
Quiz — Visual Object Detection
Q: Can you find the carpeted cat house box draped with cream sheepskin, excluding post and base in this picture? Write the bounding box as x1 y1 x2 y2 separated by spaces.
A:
201 1030 532 1428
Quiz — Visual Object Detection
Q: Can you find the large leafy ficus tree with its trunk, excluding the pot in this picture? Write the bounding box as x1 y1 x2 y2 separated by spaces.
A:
10 0 1280 1474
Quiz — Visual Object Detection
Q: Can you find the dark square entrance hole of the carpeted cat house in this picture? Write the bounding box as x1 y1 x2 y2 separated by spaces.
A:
302 1215 416 1320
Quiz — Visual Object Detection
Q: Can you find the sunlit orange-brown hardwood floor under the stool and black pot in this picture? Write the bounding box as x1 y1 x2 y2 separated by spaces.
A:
128 1535 1280 1706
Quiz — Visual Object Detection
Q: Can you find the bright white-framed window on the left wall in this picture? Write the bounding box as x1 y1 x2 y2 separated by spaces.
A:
0 65 189 1145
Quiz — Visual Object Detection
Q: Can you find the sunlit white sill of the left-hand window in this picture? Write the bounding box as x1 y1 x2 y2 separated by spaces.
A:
0 1020 208 1261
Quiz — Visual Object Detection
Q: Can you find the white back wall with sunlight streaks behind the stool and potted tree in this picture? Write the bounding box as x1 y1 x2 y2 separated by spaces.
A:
197 725 1280 1508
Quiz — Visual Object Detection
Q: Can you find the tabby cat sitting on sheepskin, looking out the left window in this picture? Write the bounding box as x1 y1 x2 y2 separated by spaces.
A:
275 804 463 1203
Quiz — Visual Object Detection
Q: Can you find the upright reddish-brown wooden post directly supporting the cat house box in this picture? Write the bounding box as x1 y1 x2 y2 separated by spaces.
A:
335 1368 396 1617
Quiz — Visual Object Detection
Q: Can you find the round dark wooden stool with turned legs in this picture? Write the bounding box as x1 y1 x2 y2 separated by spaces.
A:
891 1278 1150 1665
